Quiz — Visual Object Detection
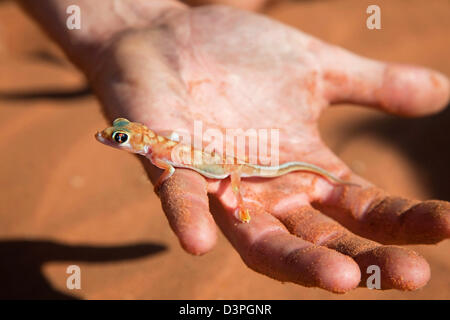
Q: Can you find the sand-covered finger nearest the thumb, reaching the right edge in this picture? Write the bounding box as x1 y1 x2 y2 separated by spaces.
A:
318 177 450 244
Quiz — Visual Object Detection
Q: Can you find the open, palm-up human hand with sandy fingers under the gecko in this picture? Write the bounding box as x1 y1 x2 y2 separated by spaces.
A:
24 1 450 293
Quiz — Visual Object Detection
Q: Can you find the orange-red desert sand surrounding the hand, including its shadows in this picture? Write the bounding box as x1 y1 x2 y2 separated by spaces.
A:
0 0 450 299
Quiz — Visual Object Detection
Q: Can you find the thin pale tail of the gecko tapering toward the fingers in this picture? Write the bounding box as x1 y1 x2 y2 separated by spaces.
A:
244 161 360 187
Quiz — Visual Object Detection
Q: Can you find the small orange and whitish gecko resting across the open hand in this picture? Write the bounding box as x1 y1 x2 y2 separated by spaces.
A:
95 118 357 223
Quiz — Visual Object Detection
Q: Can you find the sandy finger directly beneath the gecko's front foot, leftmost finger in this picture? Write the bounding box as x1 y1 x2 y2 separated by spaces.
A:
142 158 217 255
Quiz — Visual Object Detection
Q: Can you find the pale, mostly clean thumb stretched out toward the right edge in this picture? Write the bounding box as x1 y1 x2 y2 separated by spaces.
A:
320 43 450 116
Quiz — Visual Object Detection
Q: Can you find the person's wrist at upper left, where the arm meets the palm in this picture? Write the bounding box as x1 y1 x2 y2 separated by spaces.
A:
19 0 186 75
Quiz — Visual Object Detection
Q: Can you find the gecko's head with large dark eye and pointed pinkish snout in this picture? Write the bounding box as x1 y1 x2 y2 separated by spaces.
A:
95 118 148 155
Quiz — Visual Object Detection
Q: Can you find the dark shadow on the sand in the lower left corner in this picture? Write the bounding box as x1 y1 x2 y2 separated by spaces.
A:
0 239 166 299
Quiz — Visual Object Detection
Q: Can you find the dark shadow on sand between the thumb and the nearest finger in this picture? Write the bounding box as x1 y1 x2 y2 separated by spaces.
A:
342 105 450 201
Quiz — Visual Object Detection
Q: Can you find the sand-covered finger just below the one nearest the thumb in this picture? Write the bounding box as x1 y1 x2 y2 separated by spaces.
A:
277 206 430 290
